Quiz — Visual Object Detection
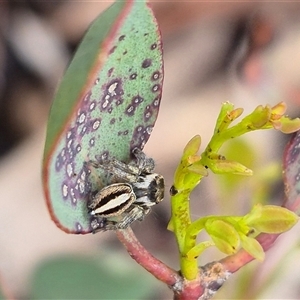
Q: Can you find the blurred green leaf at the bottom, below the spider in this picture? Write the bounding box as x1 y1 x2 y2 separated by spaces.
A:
30 253 161 299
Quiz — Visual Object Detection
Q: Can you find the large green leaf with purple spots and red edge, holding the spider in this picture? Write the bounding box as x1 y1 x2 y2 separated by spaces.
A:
43 0 163 234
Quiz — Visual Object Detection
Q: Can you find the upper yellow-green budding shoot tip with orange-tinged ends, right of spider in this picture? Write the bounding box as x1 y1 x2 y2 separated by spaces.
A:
201 102 300 175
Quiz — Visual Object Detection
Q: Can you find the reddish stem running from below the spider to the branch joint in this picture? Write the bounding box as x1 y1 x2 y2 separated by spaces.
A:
116 227 183 291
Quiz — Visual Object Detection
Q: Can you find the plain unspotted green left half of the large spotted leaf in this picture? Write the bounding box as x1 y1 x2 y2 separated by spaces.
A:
44 1 126 158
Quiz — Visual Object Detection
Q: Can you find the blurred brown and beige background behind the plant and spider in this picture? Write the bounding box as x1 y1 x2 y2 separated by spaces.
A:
0 0 300 299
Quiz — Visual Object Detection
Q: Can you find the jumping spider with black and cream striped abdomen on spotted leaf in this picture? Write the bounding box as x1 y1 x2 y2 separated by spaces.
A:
88 148 164 233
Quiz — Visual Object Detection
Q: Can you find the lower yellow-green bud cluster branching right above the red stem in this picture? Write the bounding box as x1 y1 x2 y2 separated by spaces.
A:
186 204 298 260
